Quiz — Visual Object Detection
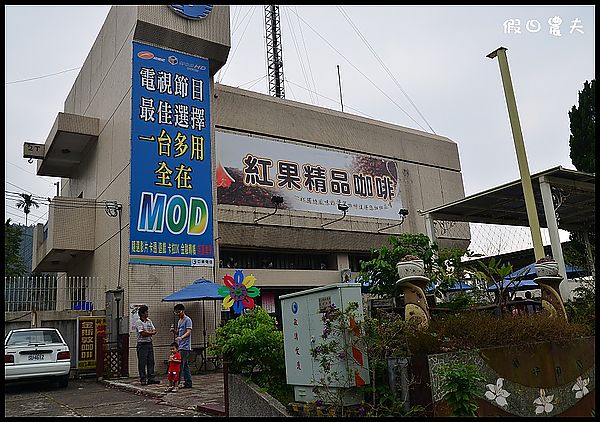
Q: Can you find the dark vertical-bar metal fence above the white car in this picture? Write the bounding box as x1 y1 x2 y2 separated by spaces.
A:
4 275 106 312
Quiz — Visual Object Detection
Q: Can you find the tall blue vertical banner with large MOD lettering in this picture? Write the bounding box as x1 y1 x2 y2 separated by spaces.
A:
129 42 214 266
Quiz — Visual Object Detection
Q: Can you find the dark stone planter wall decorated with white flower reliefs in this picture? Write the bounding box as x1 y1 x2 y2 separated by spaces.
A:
426 336 596 417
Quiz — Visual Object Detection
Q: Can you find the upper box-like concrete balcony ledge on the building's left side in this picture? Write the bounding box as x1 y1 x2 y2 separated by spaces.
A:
37 113 100 178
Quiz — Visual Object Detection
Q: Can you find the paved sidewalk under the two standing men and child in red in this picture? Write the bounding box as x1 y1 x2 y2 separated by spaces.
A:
100 371 225 416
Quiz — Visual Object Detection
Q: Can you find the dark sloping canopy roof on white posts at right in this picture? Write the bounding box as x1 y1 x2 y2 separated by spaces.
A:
423 166 596 232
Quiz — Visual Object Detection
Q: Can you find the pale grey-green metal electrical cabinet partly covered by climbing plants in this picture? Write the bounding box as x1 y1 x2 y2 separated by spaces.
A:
279 283 369 405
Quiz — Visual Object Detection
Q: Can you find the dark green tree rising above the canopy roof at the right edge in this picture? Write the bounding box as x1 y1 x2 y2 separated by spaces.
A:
569 79 596 173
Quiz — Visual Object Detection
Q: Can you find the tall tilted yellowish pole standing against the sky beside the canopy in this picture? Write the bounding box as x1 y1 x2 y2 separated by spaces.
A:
486 47 544 261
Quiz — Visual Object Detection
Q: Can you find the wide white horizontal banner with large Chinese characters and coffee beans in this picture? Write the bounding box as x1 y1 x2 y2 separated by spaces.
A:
215 131 402 219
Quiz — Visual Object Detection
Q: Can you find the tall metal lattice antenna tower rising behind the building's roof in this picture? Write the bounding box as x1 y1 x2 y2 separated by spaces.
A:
265 4 285 98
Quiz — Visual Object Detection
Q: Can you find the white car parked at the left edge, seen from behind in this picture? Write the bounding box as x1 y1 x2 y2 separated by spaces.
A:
4 328 71 387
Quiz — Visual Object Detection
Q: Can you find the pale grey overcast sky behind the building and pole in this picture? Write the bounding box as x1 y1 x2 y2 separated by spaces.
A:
5 5 595 231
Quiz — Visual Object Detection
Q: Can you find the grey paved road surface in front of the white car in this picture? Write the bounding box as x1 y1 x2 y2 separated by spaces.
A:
4 378 208 417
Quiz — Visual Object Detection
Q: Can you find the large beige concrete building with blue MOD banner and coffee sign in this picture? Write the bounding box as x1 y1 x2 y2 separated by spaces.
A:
27 5 468 373
